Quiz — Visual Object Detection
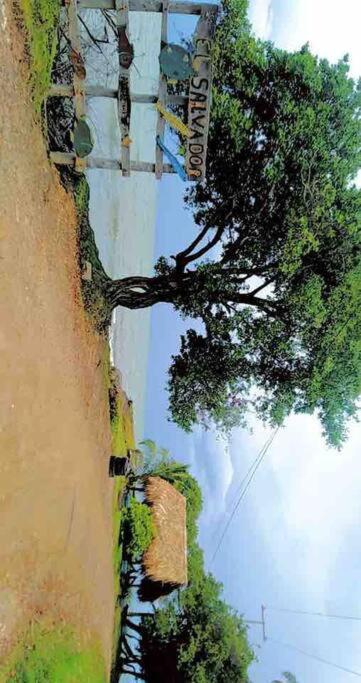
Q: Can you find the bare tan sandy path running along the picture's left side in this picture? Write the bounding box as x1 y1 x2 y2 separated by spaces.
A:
0 0 114 665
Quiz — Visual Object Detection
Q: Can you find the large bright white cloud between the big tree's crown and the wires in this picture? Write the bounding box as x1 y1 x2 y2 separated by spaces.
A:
226 416 361 599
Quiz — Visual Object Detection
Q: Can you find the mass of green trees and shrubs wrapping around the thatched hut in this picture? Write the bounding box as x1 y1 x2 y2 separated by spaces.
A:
114 440 255 683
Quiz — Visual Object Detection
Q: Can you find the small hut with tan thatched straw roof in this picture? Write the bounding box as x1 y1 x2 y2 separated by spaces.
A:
140 477 188 600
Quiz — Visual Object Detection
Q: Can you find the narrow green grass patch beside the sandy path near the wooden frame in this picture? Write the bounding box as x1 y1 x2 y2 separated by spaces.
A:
19 0 60 115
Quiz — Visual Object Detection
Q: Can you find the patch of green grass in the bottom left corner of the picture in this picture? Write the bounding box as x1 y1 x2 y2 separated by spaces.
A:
0 624 106 683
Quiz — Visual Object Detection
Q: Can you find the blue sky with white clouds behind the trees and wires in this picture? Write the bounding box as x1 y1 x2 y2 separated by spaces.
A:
145 0 361 683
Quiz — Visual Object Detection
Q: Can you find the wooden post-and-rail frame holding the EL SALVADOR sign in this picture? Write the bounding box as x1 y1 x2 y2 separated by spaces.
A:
48 0 218 180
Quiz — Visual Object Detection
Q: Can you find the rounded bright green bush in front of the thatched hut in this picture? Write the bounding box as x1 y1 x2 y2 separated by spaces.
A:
122 498 155 562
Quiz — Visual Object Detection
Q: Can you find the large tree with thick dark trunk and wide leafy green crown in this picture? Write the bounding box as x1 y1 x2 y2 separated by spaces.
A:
97 0 361 446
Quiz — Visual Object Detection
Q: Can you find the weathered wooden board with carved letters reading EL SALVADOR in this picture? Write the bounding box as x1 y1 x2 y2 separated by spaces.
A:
186 7 217 180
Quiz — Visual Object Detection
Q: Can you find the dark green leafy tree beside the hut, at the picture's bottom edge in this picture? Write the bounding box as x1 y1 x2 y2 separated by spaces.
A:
141 575 254 683
